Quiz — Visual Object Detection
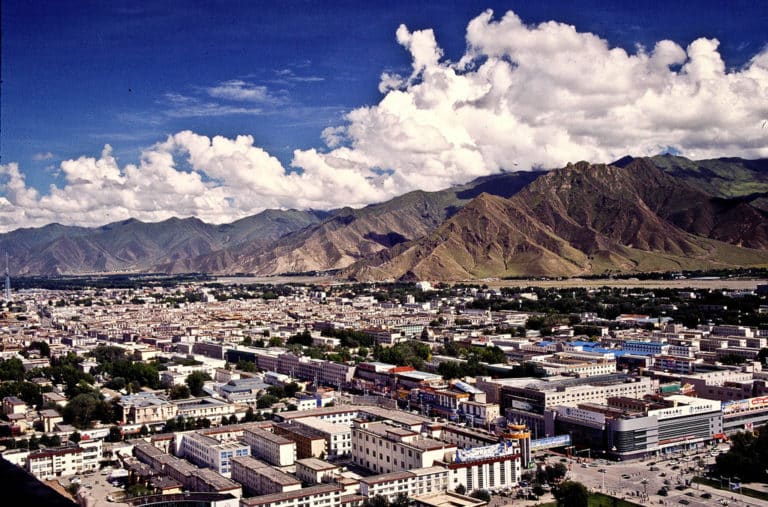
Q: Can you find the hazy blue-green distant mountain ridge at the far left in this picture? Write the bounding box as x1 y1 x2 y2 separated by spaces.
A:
0 210 326 275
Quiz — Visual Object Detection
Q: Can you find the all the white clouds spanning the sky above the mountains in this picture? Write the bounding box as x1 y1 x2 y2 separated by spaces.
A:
0 11 768 230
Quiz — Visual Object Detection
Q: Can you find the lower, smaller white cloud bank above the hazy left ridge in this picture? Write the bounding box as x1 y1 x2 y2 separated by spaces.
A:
0 131 388 231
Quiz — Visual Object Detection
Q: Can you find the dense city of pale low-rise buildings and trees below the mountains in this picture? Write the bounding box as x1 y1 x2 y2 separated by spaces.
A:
0 275 768 507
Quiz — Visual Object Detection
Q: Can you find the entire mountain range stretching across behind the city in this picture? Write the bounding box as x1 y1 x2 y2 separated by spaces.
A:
0 155 768 280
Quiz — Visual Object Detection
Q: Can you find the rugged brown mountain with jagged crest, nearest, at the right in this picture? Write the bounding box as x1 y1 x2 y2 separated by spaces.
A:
346 159 768 280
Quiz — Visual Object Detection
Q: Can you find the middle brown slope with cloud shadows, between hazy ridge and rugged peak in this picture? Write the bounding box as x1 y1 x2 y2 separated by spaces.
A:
173 172 541 275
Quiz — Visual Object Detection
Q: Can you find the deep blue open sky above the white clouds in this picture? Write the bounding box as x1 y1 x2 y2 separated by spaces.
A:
0 0 768 192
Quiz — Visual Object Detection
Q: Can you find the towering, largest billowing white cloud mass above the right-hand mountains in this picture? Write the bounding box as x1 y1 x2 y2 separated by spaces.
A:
310 10 768 190
